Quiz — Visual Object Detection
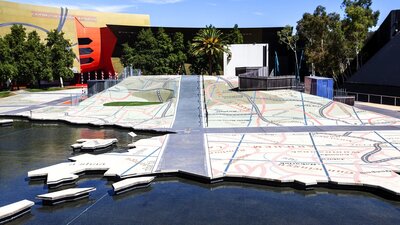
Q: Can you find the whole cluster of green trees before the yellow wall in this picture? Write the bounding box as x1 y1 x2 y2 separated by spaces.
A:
0 25 75 86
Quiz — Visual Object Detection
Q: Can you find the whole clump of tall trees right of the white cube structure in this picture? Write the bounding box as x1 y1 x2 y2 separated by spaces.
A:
297 0 379 80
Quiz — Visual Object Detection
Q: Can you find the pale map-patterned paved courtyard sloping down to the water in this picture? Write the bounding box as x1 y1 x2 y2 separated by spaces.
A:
0 76 400 197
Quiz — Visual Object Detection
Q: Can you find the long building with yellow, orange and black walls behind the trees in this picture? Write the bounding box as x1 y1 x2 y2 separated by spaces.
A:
0 1 295 76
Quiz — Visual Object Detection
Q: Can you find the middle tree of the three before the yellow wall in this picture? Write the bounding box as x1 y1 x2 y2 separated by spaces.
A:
23 31 52 88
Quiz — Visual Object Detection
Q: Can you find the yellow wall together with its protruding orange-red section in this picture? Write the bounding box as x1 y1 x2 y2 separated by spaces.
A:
0 1 150 76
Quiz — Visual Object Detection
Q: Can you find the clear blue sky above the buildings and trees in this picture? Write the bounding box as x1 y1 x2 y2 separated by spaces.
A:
3 0 400 27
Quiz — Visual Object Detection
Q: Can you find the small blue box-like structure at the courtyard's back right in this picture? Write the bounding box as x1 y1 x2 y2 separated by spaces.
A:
304 76 333 99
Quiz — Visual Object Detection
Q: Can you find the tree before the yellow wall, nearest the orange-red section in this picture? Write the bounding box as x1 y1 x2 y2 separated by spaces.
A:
46 30 75 86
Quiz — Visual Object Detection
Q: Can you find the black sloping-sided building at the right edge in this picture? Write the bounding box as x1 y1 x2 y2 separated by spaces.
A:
345 10 400 99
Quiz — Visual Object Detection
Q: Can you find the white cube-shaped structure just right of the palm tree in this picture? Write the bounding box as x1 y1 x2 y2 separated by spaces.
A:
224 44 268 76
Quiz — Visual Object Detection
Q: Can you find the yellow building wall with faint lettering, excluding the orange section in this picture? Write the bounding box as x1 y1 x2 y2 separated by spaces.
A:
0 1 150 72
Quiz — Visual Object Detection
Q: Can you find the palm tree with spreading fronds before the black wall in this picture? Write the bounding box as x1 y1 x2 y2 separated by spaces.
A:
192 25 231 75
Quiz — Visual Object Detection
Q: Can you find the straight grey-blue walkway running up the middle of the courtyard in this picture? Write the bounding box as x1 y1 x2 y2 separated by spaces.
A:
157 76 208 176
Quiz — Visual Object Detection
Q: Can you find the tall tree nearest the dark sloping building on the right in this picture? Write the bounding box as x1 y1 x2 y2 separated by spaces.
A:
342 0 379 68
